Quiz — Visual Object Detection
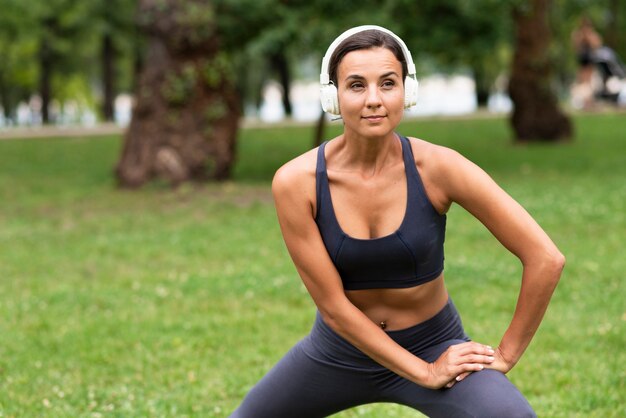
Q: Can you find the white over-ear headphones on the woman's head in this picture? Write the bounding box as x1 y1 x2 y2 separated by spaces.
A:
320 25 419 115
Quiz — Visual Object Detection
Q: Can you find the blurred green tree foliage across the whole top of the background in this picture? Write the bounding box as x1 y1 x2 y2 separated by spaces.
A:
0 0 626 122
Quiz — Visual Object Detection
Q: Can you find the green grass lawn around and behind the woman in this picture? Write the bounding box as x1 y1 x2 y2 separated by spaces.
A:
0 115 626 417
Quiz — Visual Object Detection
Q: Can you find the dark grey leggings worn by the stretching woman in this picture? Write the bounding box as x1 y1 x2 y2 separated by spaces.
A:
231 301 536 418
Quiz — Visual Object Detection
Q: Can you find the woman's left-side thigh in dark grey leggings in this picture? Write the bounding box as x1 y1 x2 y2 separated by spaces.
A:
231 344 376 418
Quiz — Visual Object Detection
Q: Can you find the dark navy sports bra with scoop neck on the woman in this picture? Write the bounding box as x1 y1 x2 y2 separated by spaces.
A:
315 136 446 290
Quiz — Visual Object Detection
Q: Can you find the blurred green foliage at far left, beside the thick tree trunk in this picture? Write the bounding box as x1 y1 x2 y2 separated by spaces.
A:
0 0 139 122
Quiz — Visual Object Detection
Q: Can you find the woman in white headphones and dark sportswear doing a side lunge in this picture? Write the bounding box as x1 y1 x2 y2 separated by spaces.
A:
232 26 564 418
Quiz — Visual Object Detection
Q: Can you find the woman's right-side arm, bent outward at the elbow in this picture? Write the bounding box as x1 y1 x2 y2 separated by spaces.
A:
434 148 565 373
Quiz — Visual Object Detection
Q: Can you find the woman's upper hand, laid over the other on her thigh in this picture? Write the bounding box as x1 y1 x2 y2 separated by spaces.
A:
422 341 495 389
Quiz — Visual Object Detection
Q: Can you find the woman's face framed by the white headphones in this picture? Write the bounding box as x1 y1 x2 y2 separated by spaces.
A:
337 48 404 137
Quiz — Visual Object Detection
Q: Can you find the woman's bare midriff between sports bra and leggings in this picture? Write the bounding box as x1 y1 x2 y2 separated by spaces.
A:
346 274 448 331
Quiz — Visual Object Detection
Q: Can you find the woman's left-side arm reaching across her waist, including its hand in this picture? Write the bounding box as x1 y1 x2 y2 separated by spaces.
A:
272 160 493 388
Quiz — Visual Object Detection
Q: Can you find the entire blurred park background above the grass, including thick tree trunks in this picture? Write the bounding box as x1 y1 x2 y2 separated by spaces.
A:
0 0 626 188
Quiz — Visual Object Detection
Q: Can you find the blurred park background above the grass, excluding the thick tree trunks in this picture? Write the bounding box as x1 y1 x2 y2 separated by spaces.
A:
0 0 626 129
